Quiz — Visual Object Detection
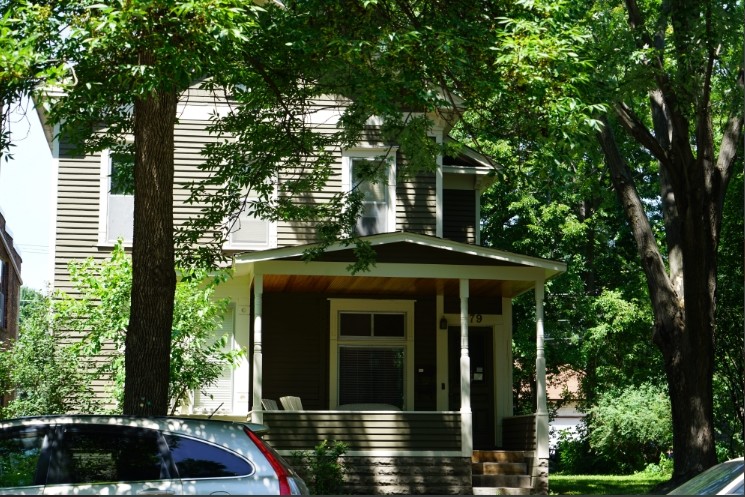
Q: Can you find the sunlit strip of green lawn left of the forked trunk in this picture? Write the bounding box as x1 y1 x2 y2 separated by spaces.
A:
548 474 670 495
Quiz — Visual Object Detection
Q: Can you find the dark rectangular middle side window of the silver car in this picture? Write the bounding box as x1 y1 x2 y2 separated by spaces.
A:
47 425 168 484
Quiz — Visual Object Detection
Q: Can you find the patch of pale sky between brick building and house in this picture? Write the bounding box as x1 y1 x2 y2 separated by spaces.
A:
0 97 54 290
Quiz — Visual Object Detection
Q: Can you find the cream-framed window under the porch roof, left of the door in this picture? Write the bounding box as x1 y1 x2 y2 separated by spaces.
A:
330 299 414 410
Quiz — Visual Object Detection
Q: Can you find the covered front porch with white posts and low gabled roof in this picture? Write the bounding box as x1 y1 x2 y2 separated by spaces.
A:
235 233 565 493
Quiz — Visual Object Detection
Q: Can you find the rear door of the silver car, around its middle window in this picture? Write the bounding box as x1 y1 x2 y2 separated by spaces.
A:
44 424 181 495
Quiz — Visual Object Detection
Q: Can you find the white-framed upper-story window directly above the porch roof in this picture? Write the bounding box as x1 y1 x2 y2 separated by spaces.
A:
342 148 396 236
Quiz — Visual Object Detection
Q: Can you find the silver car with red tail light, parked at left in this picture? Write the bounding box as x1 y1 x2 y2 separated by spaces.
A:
0 416 308 495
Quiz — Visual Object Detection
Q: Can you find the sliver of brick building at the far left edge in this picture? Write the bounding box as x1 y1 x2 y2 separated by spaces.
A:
0 211 23 405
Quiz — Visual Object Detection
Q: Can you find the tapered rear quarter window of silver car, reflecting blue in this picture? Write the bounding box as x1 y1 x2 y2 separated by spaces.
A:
165 435 253 479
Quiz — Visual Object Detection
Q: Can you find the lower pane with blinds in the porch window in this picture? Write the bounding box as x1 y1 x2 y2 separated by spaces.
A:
339 345 405 409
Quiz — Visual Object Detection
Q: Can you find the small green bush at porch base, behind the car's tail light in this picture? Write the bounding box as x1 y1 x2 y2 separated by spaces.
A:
292 440 347 495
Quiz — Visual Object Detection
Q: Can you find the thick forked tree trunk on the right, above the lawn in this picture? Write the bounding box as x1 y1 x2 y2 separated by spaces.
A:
598 109 733 481
